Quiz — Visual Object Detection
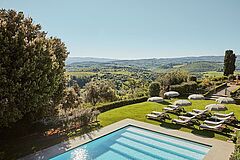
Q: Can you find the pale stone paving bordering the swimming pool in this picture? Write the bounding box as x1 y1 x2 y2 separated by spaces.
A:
20 119 234 160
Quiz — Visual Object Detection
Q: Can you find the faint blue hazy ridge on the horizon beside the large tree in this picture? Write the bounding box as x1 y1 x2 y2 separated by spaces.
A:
66 57 116 64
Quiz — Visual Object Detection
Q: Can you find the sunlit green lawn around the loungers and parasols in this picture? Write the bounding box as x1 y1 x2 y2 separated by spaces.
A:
99 100 240 140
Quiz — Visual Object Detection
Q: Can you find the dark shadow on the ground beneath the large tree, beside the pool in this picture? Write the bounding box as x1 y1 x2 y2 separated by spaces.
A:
0 123 100 160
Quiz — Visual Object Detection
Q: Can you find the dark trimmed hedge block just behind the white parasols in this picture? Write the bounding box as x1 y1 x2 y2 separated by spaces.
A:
170 81 198 95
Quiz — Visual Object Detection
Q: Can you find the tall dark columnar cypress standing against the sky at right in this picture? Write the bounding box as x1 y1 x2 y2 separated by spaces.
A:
223 50 236 76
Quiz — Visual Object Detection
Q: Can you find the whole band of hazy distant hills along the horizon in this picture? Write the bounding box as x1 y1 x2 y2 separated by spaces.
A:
66 55 240 72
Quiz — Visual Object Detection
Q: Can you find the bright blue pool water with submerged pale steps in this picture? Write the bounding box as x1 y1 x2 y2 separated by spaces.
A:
51 126 210 160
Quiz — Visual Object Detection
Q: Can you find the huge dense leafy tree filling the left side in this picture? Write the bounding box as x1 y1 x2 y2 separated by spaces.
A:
0 9 68 127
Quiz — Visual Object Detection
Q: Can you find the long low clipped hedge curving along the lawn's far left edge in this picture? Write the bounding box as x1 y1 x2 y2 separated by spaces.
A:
97 97 148 113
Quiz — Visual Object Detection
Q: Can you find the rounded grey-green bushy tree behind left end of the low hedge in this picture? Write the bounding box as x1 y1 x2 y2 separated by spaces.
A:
85 80 116 106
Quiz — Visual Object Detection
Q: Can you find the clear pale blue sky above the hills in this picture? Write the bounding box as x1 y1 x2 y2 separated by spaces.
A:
0 0 240 59
